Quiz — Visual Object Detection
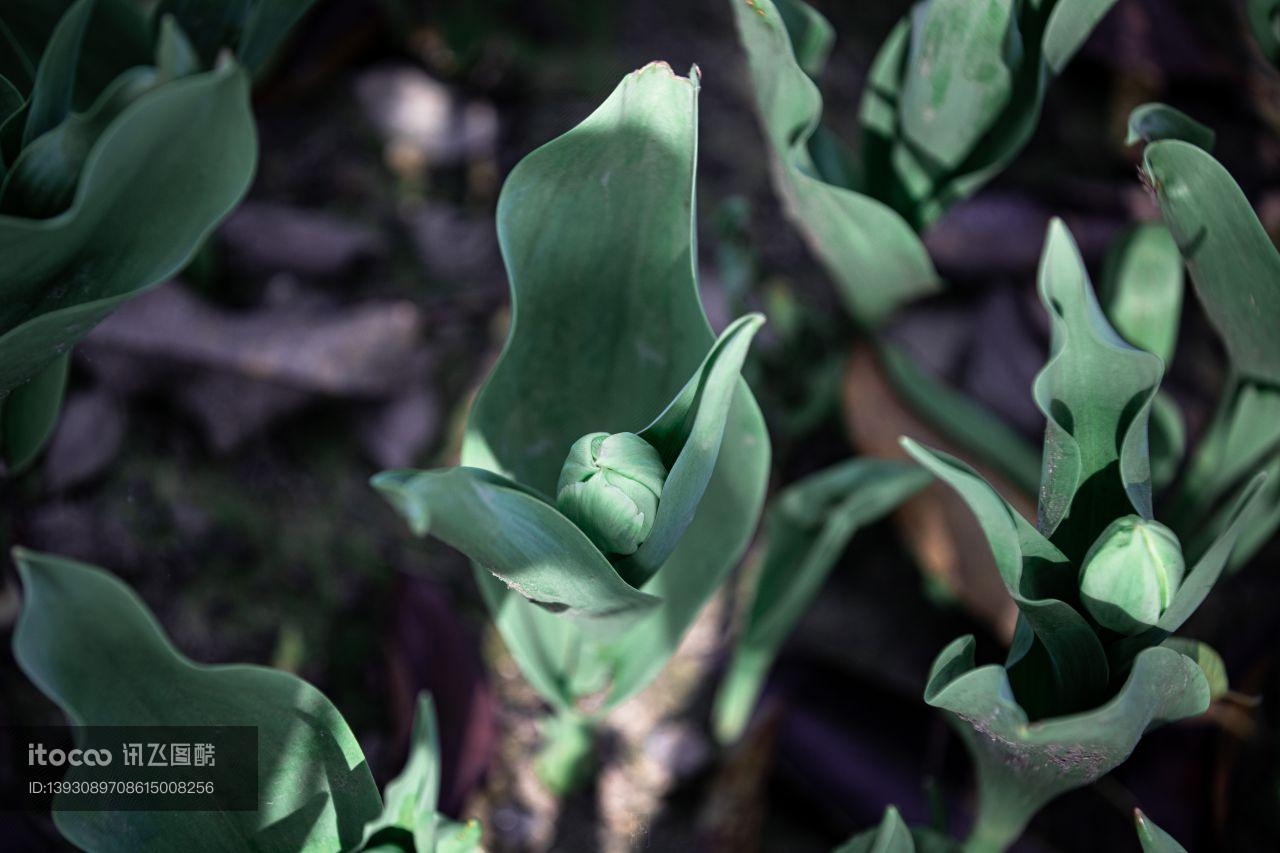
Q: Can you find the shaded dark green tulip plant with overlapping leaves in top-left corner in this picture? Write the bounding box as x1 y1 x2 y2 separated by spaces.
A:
0 0 310 471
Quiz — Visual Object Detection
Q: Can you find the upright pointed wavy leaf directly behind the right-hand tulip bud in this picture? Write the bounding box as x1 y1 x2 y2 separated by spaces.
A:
1034 219 1164 560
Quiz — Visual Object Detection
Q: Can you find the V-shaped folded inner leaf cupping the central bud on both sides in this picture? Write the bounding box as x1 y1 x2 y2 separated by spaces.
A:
372 308 764 627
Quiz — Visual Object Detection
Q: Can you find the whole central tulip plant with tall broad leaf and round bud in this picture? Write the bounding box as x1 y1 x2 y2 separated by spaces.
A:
374 64 769 790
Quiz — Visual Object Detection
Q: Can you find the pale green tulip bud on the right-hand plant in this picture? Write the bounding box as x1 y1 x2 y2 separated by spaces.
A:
1080 515 1187 634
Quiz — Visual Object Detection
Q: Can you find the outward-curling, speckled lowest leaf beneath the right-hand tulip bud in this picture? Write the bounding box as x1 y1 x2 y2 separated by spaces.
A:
924 637 1210 850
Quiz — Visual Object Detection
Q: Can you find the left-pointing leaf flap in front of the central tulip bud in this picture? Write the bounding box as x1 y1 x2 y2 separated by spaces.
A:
372 467 658 633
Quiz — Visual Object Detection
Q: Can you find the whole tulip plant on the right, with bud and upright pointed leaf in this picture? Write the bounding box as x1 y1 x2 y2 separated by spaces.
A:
829 222 1267 852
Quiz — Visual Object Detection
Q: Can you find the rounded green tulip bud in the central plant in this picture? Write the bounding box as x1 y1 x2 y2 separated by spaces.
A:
556 433 667 556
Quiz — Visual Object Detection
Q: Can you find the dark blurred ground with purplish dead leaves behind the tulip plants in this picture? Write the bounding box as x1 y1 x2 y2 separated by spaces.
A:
0 0 1280 852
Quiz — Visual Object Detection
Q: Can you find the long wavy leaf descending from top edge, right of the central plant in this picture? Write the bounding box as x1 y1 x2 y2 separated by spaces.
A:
731 0 938 325
